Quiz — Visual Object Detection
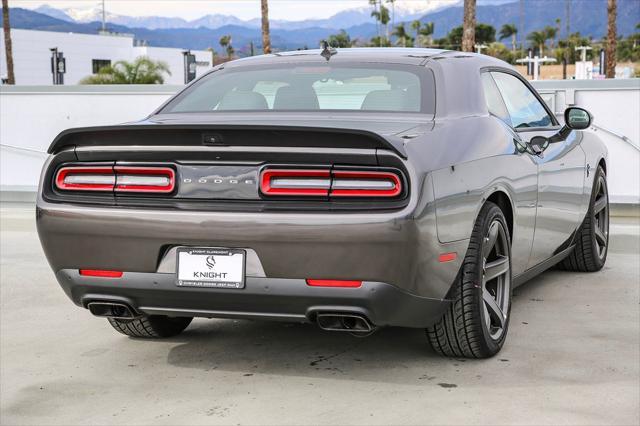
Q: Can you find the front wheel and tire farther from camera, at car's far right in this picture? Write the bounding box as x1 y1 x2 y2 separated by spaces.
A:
558 166 609 272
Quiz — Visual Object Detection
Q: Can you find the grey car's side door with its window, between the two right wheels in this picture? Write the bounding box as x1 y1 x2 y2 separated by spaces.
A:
491 71 586 268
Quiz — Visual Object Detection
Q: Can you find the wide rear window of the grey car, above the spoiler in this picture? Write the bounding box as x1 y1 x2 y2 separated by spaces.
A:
161 64 435 114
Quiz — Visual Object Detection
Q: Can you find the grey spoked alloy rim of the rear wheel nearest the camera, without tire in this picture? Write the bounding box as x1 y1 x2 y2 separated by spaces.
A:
482 219 511 340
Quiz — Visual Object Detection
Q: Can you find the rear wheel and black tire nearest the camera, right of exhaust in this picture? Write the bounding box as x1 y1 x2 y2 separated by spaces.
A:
427 202 512 358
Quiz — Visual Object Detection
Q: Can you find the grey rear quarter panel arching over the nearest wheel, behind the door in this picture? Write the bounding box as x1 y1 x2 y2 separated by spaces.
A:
407 116 537 275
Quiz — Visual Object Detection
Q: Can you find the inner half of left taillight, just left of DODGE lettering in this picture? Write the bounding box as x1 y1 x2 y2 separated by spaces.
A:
113 166 176 194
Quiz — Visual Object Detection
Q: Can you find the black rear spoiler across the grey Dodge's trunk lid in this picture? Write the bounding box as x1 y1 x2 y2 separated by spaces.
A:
47 124 407 159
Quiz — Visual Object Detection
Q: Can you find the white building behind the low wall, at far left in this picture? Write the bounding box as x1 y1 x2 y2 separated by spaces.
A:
0 29 211 85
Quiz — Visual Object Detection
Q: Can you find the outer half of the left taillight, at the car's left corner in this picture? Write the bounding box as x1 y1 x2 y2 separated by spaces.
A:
56 166 116 191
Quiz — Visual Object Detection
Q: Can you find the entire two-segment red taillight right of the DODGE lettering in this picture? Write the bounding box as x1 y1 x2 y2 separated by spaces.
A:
260 169 403 198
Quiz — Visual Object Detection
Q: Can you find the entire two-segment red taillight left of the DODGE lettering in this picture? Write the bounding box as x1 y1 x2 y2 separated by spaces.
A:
55 166 176 194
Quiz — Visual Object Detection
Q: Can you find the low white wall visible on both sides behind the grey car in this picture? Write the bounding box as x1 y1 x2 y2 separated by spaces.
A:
0 79 640 204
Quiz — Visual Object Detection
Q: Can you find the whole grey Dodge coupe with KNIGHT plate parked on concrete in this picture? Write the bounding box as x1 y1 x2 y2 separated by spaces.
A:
37 48 609 358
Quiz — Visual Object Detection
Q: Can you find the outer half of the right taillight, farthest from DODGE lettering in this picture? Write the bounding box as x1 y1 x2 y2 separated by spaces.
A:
329 170 402 197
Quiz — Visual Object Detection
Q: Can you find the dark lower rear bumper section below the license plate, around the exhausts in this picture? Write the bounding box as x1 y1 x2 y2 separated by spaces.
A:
56 269 449 328
